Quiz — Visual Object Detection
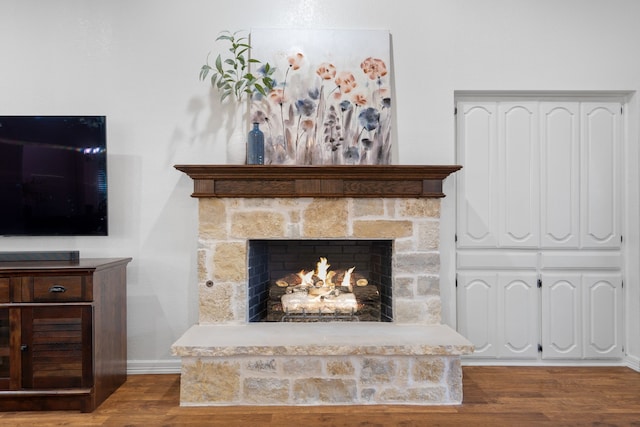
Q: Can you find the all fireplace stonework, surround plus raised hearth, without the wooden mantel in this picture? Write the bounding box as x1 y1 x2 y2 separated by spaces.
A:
173 197 472 406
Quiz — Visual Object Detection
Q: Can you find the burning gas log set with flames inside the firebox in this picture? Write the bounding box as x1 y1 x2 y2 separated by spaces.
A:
266 257 381 322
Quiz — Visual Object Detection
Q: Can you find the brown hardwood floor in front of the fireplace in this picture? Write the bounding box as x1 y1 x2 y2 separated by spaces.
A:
0 366 640 427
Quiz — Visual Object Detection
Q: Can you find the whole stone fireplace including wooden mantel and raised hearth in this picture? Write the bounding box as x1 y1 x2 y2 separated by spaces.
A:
172 165 473 406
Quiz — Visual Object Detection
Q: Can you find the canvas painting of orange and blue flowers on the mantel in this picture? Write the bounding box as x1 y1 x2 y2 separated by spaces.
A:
250 29 392 165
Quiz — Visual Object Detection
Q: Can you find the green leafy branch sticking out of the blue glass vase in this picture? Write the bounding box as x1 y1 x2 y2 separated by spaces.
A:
200 31 276 102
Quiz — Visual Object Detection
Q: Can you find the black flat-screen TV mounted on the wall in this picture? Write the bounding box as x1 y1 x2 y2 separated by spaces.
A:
0 116 108 236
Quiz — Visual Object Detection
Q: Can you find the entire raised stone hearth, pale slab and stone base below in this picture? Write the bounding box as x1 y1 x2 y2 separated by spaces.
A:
172 322 473 406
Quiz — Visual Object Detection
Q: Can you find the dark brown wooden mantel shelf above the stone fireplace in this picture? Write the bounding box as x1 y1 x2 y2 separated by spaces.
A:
174 165 462 198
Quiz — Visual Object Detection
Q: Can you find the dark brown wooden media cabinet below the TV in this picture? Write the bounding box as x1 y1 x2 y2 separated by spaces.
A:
0 258 131 412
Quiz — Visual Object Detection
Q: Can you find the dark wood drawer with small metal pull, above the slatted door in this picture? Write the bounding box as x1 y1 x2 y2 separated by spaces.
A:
22 276 93 302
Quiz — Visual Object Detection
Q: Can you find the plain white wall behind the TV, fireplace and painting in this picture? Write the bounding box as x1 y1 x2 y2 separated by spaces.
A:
0 0 640 371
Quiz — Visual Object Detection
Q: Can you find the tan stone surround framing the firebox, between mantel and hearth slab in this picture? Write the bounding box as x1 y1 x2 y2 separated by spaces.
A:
198 198 441 324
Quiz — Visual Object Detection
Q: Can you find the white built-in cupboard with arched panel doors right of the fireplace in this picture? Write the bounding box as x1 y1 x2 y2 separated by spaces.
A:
456 97 623 360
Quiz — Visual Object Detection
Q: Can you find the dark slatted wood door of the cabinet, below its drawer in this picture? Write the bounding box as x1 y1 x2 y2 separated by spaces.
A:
20 305 93 389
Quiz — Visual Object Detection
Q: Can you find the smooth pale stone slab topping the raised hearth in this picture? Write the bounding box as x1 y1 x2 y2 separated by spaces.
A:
172 322 473 357
